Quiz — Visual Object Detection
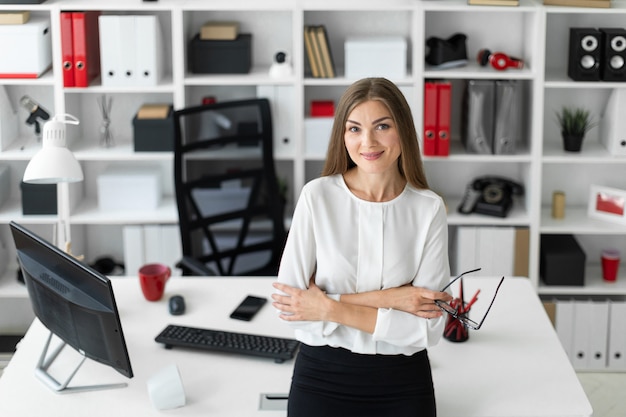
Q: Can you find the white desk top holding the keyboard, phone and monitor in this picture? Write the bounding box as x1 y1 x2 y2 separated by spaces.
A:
0 278 592 417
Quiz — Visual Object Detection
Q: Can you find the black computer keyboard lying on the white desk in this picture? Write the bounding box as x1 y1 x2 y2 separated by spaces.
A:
154 324 300 363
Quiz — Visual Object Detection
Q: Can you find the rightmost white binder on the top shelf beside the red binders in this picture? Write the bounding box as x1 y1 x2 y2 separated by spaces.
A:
133 15 163 86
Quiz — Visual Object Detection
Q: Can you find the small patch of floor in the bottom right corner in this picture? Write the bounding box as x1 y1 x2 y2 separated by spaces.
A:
578 372 626 417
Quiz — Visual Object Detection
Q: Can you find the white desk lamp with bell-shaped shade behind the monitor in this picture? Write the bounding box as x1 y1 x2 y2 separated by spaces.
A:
24 114 83 253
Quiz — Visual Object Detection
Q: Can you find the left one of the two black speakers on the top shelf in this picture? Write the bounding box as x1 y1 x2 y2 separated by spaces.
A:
567 28 602 81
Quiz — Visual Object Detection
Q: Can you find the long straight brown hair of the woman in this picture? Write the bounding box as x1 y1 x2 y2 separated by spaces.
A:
322 78 428 189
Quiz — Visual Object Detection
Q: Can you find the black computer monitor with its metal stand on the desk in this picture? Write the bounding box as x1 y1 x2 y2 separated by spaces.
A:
10 222 133 393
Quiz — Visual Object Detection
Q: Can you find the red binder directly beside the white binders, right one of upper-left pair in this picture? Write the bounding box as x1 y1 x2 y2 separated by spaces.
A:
72 11 100 87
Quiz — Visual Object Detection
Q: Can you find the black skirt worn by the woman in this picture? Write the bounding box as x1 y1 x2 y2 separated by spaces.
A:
287 344 437 417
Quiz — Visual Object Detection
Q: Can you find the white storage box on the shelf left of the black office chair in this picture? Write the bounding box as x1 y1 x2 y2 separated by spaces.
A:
97 167 161 211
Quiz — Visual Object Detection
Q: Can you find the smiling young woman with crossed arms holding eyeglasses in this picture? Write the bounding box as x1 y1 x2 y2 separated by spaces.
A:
273 78 452 417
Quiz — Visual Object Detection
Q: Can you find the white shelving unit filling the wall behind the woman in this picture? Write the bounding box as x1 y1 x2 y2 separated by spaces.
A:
0 0 626 330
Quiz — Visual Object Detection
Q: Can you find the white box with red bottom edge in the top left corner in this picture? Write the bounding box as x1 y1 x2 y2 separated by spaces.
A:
0 18 52 78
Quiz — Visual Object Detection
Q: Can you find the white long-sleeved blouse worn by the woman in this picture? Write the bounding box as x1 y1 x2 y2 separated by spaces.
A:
278 175 450 355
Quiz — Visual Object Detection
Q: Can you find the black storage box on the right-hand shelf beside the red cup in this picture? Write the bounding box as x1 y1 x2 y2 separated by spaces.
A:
539 235 586 286
